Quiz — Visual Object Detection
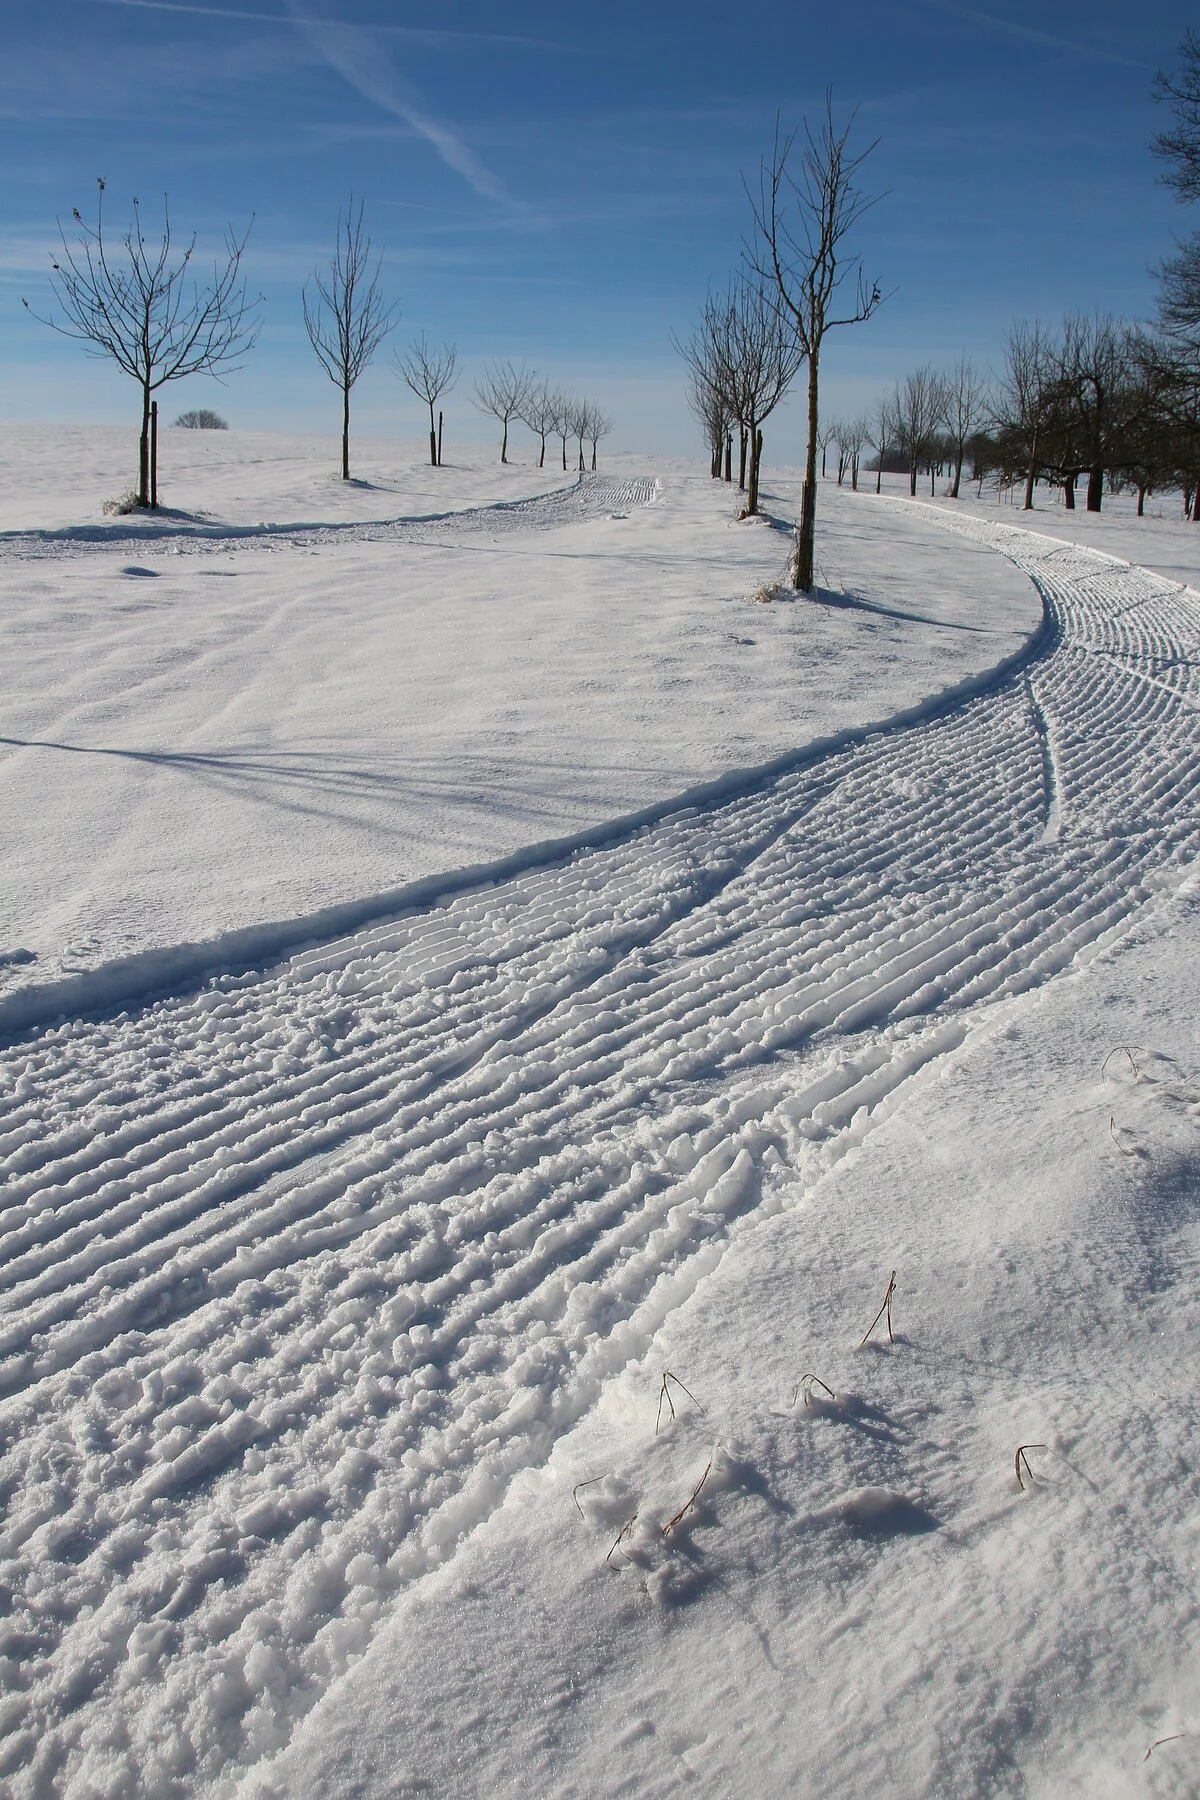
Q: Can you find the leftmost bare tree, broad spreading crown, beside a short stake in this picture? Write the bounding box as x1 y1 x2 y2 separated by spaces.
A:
23 178 259 506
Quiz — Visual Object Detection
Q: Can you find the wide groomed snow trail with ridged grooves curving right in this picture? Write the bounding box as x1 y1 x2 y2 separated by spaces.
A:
0 490 1200 1800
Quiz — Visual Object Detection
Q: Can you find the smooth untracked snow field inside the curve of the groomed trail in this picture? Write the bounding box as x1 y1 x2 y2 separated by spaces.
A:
0 428 1040 1024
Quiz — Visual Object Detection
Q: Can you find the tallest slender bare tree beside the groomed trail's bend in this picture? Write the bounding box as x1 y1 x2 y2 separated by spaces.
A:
750 94 883 594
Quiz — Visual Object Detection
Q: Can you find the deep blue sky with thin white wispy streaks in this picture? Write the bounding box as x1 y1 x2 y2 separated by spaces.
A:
0 0 1200 457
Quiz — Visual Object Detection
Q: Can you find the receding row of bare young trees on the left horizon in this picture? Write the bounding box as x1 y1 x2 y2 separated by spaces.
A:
23 180 612 509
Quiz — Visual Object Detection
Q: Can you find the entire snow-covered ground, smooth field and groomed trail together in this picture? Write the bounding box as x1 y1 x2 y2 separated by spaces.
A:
0 428 1200 1800
